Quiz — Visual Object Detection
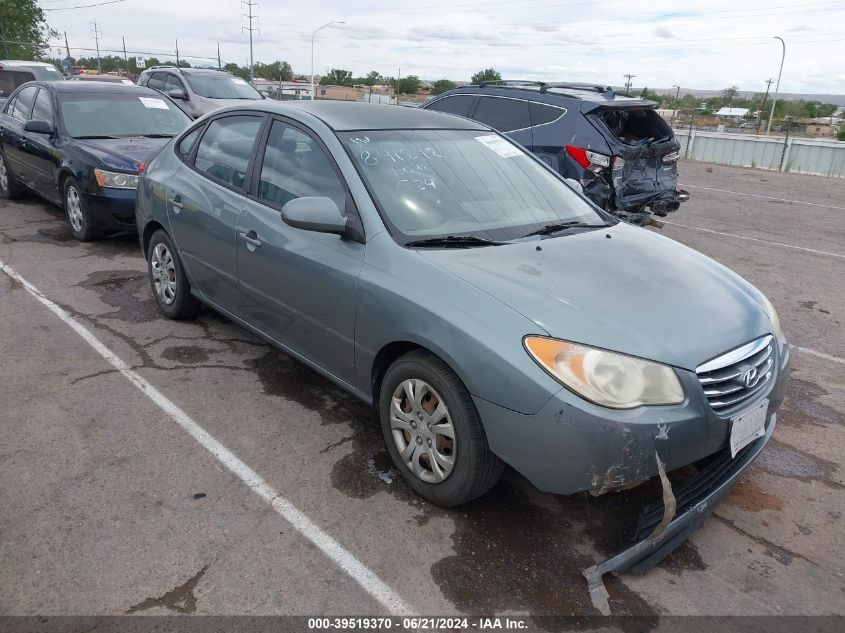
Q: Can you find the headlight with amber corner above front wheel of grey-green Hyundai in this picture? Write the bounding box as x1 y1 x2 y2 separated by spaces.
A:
525 336 684 409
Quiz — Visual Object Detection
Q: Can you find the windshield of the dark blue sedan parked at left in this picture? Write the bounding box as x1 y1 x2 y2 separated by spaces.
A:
59 88 191 138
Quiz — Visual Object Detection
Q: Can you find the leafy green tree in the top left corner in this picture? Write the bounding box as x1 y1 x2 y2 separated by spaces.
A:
0 0 58 61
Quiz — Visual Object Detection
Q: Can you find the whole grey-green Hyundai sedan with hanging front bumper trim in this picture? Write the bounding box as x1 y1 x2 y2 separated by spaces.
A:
136 101 789 568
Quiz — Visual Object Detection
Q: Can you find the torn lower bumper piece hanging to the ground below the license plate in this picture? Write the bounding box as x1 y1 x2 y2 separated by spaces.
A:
582 414 777 615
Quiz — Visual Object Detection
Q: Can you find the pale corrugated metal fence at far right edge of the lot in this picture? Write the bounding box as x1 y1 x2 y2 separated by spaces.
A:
675 129 845 178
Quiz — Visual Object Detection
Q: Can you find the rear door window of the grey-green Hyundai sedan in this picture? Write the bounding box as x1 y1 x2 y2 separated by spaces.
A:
194 115 263 189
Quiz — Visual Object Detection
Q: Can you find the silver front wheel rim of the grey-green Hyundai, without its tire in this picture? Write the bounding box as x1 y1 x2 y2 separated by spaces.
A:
390 378 457 483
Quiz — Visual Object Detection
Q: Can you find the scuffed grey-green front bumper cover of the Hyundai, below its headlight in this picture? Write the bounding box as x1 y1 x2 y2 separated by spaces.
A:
474 347 789 494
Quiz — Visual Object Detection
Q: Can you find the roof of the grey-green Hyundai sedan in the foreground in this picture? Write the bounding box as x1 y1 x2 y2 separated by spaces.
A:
233 100 490 132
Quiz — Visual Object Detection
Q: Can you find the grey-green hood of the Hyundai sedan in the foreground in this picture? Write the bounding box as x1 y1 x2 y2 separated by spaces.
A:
418 223 771 371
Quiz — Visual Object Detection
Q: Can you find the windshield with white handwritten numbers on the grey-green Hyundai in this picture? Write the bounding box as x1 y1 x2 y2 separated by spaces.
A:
339 130 606 243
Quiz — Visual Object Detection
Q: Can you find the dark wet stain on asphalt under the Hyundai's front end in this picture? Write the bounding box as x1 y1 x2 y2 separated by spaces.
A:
247 350 680 626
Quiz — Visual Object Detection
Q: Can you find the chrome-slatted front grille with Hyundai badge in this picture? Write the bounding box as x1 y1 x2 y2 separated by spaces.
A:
695 336 775 417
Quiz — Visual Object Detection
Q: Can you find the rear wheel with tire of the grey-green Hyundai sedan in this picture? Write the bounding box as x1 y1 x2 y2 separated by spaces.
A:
147 229 201 319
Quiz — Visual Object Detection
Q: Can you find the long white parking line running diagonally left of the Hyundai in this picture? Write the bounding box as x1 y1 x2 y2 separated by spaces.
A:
0 261 414 615
